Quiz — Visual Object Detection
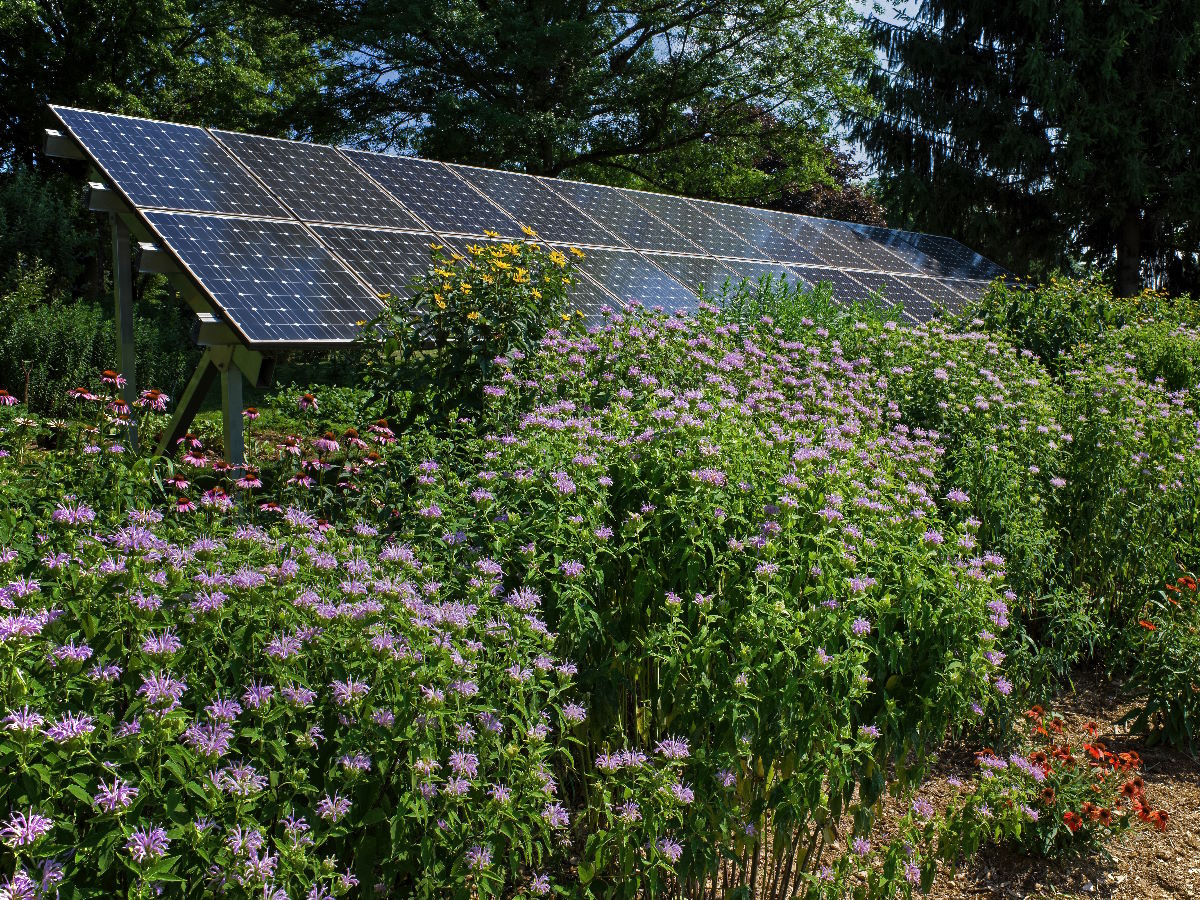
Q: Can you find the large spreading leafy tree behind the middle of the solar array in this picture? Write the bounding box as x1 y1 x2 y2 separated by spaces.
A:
328 0 866 195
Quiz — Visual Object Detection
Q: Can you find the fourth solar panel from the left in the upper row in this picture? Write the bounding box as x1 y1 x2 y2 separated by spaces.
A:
449 166 624 247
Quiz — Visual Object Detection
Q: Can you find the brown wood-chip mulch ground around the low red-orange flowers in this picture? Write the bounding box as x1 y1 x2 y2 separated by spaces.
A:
881 672 1200 900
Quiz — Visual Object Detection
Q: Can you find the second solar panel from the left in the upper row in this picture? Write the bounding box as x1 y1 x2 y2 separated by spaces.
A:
212 131 424 228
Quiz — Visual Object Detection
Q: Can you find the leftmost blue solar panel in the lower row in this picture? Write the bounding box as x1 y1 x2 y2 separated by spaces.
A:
145 211 383 344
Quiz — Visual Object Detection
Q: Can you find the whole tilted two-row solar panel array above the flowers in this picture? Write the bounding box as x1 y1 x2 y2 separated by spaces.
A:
52 107 1007 347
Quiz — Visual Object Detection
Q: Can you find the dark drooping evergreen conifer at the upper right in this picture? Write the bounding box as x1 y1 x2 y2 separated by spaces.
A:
856 0 1200 295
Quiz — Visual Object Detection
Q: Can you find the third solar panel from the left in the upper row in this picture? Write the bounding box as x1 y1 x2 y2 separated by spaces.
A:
346 150 521 238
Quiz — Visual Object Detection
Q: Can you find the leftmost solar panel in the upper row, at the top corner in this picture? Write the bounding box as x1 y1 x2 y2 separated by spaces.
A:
52 107 292 218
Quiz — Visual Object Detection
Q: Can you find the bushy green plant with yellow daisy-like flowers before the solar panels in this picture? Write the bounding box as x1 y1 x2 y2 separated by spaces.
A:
359 240 582 421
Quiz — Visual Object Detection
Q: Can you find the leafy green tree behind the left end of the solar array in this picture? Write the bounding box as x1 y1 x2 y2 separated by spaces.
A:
0 0 348 167
